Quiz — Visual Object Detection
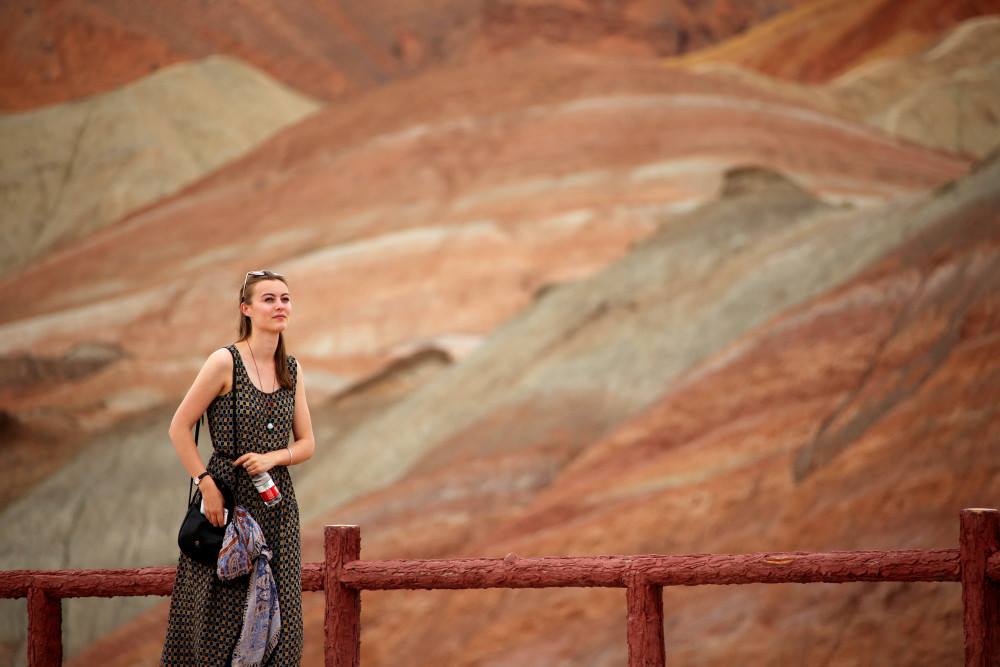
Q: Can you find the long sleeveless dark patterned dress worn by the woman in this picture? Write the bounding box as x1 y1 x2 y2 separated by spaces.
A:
160 344 303 667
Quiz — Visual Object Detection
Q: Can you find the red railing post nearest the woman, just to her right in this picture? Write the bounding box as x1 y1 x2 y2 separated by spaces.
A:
323 526 361 667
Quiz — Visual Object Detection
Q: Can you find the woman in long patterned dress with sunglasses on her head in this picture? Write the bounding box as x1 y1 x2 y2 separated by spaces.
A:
160 271 315 667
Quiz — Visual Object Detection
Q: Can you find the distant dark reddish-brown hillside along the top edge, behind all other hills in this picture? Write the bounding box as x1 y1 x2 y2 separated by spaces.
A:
0 0 798 111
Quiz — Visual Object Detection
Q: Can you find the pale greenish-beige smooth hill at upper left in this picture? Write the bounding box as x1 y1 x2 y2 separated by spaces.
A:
0 52 319 280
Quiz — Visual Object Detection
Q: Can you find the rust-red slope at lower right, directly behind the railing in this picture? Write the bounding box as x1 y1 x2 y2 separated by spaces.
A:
346 155 1000 666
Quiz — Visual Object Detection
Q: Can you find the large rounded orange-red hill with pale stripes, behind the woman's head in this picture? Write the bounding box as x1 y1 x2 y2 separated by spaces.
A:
0 44 966 504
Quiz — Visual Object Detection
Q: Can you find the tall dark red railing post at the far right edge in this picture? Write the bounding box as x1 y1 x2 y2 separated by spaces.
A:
959 508 1000 667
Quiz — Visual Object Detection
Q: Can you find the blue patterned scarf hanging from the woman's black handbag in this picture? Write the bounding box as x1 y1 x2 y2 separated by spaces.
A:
218 505 281 667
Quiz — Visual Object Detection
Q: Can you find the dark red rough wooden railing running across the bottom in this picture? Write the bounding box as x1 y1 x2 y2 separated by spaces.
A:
0 509 1000 667
